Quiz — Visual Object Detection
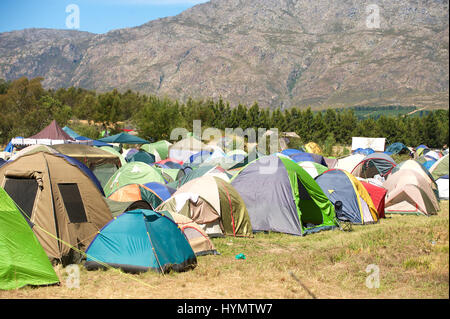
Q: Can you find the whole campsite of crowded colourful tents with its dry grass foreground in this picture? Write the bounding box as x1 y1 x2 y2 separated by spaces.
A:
0 121 449 299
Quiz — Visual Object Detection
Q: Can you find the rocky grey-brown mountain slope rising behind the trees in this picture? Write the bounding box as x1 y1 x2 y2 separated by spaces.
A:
0 0 449 108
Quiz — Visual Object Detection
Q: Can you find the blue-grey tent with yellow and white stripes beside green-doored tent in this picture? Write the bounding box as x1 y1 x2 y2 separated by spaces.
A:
315 169 378 224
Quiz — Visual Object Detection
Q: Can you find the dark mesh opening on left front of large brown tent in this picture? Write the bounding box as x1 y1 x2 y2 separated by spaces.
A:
3 177 38 220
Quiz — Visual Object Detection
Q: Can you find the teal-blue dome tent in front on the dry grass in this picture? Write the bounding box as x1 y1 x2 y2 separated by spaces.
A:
84 209 197 273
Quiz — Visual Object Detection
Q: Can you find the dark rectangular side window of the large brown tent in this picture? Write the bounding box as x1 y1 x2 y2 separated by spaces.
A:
58 184 87 223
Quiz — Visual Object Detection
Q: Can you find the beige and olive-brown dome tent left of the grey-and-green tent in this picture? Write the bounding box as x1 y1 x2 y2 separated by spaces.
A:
157 176 252 236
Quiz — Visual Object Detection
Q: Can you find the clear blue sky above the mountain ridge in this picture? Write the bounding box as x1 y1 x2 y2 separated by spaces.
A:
0 0 207 33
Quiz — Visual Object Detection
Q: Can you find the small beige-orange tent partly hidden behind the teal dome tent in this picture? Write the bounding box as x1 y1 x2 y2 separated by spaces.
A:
164 212 219 256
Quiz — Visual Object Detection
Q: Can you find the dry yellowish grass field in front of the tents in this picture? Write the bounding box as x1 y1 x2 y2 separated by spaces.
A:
0 201 449 299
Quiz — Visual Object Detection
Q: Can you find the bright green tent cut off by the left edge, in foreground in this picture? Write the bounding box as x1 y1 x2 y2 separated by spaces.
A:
0 187 59 290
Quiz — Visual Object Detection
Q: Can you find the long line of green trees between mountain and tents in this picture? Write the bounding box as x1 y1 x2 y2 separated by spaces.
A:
0 77 449 148
